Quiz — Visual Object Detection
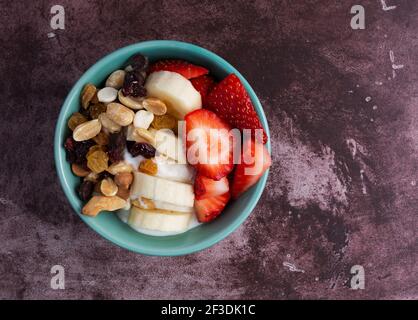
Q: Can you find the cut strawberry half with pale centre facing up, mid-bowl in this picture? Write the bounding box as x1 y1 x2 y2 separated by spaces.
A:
184 109 234 180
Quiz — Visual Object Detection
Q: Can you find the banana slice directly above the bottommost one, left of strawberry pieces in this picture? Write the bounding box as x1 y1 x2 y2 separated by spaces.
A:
131 171 194 207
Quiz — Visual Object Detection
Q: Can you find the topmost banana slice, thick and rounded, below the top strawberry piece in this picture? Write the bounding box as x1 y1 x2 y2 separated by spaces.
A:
145 71 202 119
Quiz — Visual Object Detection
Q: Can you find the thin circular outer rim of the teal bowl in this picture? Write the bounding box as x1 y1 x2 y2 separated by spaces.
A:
54 40 271 256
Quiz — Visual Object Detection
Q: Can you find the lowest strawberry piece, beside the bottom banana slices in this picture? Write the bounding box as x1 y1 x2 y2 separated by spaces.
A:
194 192 231 222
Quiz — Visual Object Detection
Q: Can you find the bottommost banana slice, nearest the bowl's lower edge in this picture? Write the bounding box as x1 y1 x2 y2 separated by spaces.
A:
128 207 192 232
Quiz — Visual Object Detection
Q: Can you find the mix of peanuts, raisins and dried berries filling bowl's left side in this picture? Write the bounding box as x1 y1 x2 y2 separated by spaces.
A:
64 54 177 216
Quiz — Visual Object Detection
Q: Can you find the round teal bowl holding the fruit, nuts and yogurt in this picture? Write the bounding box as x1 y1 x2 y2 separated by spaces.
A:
54 40 271 256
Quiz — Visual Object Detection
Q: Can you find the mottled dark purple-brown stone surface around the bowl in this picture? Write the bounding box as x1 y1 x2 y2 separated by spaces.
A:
0 0 418 299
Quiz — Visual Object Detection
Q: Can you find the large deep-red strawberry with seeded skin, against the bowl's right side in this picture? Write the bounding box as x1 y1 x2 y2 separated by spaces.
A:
206 74 267 143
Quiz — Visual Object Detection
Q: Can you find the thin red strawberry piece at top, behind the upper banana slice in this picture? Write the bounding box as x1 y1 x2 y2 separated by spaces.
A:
150 59 209 79
